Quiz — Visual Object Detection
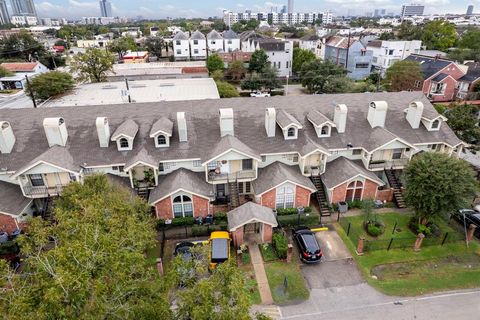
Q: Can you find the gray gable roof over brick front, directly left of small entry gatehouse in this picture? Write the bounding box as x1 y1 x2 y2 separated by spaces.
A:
148 168 213 205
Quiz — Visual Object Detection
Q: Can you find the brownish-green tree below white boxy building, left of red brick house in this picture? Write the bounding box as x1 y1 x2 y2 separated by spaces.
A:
385 60 423 91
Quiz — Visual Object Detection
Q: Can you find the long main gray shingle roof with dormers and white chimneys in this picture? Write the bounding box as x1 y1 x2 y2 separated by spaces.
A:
0 92 461 171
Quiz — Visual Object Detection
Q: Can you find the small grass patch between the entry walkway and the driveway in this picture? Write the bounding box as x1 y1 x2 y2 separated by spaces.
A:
265 262 310 305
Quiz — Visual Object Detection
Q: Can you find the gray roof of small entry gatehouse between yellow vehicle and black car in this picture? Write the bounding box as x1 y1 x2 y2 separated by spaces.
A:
227 202 278 231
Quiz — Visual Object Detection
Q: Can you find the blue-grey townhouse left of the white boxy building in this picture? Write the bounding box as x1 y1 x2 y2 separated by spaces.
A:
325 36 373 80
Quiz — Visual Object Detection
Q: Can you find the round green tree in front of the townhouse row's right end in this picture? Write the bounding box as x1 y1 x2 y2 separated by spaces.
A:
403 152 477 225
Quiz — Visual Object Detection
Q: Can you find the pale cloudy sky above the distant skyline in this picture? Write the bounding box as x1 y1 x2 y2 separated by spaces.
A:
28 0 480 19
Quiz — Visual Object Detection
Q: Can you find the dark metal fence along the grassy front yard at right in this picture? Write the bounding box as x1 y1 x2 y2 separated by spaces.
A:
340 218 465 252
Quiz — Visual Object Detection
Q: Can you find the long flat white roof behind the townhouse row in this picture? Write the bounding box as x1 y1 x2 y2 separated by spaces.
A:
42 78 220 107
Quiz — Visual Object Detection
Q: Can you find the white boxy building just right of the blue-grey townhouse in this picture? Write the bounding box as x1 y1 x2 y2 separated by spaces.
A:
367 40 422 76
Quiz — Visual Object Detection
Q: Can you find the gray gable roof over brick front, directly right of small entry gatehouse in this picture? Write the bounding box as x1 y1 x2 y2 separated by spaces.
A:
253 162 316 195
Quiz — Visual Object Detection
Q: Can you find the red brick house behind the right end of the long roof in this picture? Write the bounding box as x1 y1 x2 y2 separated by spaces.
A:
405 54 466 102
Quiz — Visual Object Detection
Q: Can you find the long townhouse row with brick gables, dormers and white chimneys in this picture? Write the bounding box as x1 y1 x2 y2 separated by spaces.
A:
0 92 463 237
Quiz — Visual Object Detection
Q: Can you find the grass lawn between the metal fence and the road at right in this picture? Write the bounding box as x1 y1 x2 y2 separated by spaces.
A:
336 220 480 296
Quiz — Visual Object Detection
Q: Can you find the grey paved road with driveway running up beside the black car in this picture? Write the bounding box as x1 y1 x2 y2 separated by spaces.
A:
280 231 480 320
